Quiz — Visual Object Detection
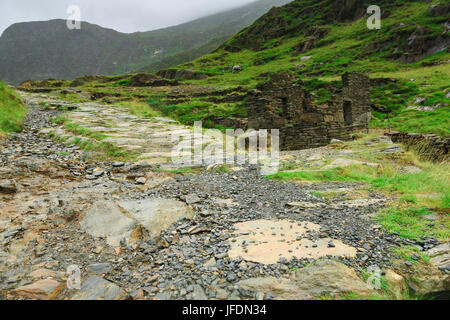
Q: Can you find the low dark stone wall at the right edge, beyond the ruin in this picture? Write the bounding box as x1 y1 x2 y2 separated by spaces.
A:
386 132 450 162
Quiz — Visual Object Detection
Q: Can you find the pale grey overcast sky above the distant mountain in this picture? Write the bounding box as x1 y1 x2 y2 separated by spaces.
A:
0 0 257 34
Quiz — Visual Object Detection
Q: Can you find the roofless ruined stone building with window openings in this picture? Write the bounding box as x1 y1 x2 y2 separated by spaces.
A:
247 73 370 150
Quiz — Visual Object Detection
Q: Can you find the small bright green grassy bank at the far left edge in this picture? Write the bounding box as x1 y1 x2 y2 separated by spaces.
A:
0 81 27 136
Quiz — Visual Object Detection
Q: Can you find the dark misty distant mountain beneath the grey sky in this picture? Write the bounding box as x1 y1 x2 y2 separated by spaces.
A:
0 0 290 84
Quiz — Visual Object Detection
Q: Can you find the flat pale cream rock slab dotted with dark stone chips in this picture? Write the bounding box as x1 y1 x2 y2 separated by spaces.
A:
228 220 357 264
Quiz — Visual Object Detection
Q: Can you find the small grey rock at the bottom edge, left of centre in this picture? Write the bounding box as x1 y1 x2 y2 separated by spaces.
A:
71 277 128 300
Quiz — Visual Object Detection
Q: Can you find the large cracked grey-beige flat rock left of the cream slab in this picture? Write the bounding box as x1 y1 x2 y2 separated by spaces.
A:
81 199 194 247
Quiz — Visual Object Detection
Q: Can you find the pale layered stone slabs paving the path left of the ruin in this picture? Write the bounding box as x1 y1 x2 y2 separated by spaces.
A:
23 93 225 168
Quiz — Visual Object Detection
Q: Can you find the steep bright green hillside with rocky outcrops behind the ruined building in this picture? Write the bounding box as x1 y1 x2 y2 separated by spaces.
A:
166 0 450 135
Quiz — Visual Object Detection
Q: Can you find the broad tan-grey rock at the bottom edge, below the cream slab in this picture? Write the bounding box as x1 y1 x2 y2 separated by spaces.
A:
238 260 375 300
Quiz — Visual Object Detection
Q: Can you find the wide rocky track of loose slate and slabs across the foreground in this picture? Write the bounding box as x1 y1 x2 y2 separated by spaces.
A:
0 92 446 299
